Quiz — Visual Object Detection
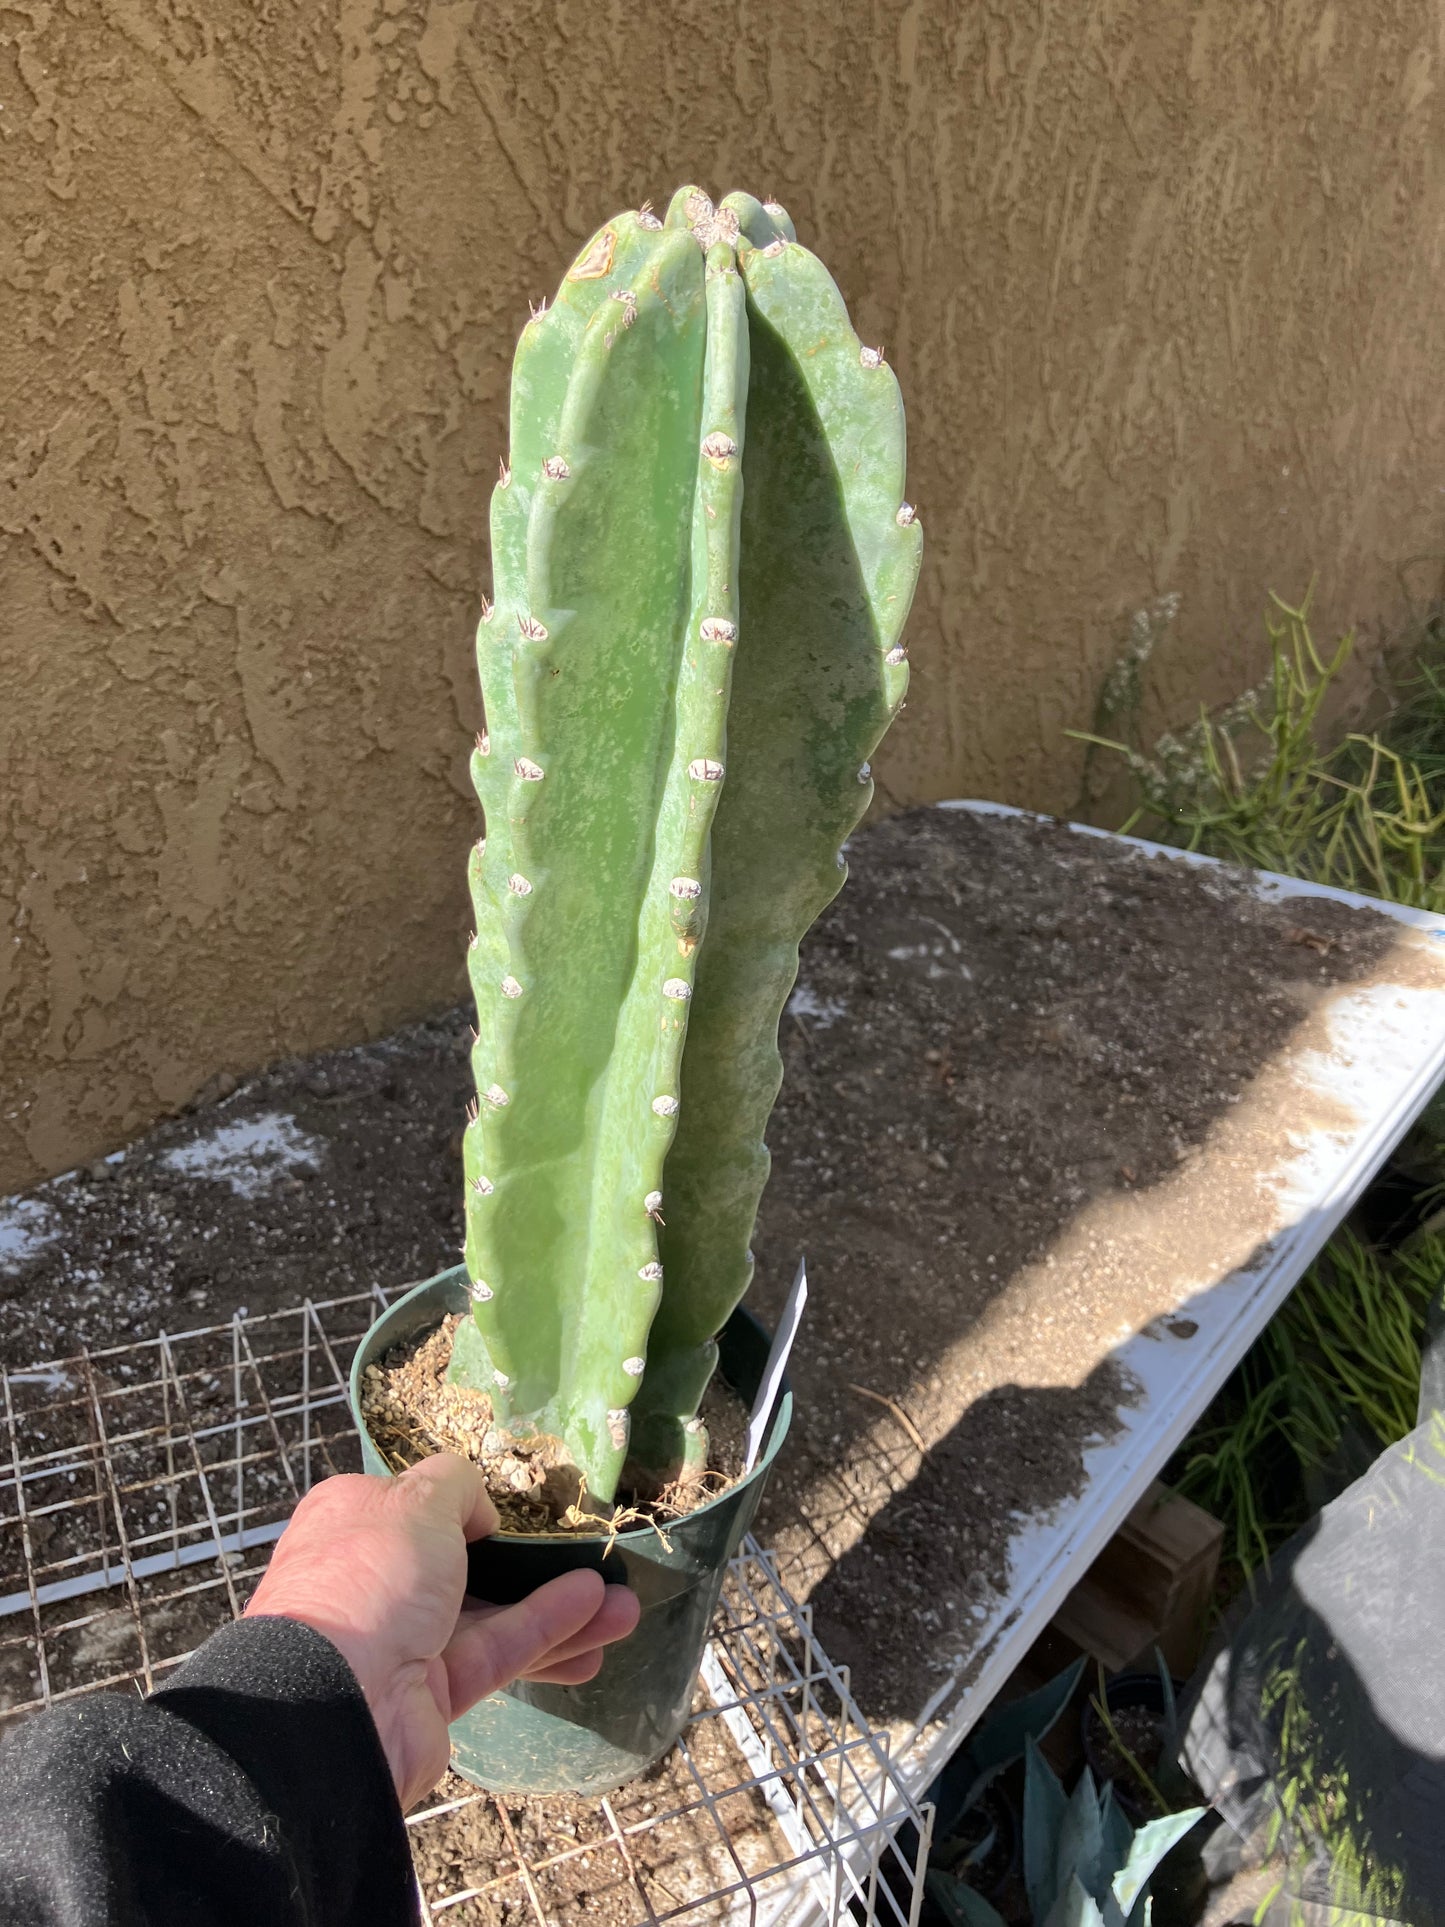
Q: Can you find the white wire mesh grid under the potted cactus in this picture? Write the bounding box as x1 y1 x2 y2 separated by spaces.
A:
0 1291 931 1927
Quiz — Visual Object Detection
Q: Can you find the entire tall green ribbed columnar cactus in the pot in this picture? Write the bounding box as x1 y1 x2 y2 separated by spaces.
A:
451 187 923 1503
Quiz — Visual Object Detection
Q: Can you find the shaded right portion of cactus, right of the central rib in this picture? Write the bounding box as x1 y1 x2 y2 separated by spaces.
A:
636 197 921 1459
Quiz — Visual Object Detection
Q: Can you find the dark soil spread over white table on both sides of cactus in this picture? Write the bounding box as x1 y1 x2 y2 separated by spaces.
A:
0 809 1410 1721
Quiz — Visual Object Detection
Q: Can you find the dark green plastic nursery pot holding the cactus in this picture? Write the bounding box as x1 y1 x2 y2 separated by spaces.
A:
351 1266 792 1794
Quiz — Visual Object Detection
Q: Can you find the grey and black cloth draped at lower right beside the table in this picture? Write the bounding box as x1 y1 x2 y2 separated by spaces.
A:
1183 1411 1445 1927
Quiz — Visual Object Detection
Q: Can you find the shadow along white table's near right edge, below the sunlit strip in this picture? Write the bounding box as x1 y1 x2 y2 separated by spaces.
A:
805 1174 1445 1734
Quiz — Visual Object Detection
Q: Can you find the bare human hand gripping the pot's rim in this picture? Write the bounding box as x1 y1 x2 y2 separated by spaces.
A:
247 1453 640 1811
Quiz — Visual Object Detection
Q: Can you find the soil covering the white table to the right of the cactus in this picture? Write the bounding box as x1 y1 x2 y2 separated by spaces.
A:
735 809 1414 1723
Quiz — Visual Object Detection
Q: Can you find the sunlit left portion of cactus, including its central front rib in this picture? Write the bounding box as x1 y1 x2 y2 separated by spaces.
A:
453 211 748 1499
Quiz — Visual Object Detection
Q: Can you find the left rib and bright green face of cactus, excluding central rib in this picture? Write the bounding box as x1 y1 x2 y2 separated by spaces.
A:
457 220 705 1456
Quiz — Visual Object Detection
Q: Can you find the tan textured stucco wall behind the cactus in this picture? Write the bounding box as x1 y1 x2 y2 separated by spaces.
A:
0 0 1445 1191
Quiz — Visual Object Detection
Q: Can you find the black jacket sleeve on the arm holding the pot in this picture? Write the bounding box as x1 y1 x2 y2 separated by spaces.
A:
0 1619 418 1927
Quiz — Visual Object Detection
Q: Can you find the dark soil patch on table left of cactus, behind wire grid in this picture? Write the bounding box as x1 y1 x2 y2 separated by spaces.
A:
0 1010 472 1366
